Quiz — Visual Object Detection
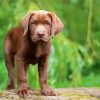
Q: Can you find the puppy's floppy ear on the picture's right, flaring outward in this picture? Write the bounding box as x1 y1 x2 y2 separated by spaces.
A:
49 13 64 37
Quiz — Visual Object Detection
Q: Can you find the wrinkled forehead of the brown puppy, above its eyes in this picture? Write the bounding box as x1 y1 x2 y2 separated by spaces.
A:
30 11 51 22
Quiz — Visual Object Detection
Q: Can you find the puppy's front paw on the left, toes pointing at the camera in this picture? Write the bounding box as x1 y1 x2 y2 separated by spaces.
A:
18 83 28 98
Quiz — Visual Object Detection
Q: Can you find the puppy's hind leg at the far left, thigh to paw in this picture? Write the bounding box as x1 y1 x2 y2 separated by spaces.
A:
5 38 14 90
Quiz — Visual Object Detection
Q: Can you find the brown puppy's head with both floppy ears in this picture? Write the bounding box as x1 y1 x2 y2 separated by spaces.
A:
20 10 63 42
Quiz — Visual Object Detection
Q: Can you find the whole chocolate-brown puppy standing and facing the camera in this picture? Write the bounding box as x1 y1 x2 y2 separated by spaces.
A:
4 10 63 97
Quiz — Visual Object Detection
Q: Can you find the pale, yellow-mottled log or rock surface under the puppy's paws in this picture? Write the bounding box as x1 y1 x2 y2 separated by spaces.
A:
0 88 100 100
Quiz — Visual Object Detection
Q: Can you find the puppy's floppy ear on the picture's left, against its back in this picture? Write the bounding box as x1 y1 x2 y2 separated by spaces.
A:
19 12 33 36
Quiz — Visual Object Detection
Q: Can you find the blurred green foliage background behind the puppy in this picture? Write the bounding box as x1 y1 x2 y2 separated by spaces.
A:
0 0 100 89
